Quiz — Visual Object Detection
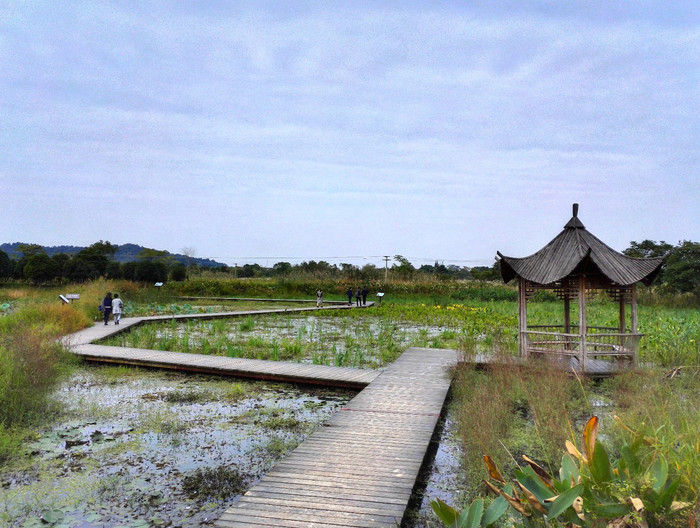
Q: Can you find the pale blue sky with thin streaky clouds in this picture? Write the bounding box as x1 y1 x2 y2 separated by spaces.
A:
0 0 700 267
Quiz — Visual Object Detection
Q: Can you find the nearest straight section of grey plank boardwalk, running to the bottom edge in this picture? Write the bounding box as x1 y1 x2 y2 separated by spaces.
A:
216 348 458 528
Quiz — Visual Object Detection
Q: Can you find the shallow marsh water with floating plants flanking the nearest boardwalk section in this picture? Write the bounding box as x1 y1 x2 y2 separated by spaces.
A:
0 365 460 528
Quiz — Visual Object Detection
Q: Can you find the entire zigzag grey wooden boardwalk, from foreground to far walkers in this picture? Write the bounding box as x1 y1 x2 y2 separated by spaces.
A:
63 307 459 528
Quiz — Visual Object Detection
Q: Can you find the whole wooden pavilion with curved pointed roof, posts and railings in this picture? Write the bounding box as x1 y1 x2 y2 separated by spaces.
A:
497 204 663 374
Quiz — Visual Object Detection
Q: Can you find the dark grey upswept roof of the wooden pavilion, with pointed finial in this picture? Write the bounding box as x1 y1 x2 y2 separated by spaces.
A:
498 204 663 286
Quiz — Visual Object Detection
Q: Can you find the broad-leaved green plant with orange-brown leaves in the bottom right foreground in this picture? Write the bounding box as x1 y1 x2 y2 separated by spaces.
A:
431 416 695 528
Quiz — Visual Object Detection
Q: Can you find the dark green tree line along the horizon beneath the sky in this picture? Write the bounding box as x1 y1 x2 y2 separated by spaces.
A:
0 240 700 300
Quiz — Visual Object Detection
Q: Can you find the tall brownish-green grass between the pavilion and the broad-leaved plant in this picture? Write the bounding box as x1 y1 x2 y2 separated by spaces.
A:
452 350 700 507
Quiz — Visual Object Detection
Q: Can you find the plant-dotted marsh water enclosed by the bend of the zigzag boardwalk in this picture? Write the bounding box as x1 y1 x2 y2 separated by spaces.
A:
105 314 458 369
